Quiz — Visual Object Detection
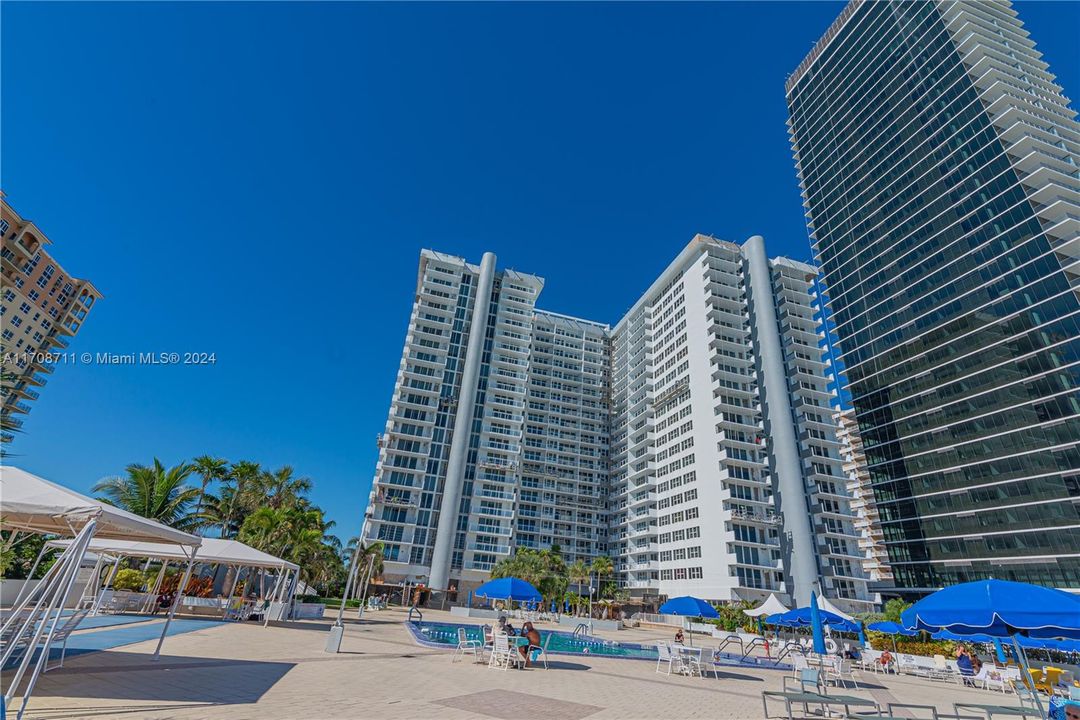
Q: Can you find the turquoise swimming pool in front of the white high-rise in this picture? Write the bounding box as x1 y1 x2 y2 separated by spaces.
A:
405 622 787 669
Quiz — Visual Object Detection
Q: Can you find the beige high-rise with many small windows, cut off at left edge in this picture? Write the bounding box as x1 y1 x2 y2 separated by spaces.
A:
0 196 102 443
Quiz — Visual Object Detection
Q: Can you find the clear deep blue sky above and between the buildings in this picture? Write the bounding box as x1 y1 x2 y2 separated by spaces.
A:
0 2 1080 536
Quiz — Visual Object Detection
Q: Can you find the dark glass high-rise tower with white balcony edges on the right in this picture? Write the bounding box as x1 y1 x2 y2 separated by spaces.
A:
787 0 1080 596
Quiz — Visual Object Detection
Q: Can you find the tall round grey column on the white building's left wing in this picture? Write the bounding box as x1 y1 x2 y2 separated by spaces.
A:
428 253 495 590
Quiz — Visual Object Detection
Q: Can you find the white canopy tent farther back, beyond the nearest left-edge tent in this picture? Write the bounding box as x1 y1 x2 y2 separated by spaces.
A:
49 538 300 621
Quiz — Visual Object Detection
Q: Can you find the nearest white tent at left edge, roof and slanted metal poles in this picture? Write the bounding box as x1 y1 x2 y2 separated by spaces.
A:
0 466 202 718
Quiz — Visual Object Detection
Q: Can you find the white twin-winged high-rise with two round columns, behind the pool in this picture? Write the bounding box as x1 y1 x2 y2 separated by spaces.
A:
364 235 868 611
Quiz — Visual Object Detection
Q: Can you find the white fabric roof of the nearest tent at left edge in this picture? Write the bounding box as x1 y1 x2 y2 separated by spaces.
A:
0 466 202 546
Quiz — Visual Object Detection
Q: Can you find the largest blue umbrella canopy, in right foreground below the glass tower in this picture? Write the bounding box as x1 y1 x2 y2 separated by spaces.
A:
901 580 1080 640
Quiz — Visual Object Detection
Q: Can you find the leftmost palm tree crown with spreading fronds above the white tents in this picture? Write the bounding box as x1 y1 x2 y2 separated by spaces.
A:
93 458 202 530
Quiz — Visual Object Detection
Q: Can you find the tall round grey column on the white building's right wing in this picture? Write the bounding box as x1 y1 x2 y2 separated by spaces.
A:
743 235 819 608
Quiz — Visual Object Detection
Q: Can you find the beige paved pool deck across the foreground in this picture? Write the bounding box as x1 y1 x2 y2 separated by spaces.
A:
3 610 1015 720
